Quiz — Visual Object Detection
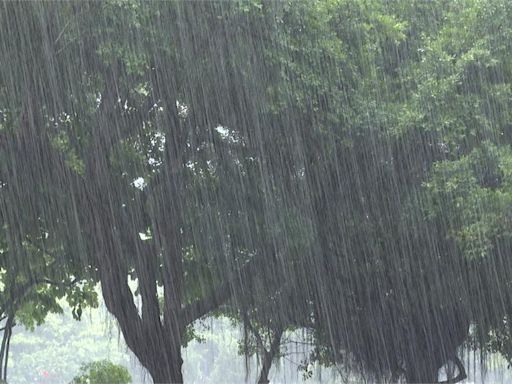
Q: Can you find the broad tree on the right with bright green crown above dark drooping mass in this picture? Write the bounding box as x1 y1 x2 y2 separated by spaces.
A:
256 2 510 382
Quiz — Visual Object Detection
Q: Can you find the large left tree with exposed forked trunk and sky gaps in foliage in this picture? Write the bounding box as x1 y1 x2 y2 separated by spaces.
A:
1 2 288 382
